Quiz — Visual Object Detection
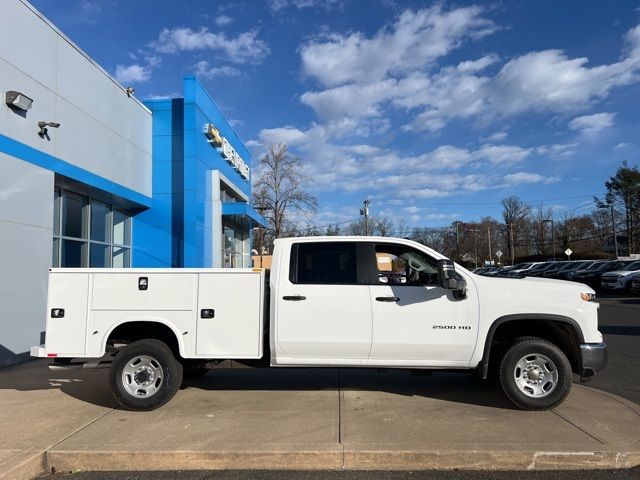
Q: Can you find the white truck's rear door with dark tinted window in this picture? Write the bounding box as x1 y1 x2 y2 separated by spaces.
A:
275 241 371 365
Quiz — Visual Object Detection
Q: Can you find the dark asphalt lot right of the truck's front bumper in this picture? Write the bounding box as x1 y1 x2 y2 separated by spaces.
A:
587 297 640 404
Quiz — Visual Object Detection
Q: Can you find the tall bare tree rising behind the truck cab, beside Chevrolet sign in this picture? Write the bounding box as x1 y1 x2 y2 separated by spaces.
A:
254 144 318 249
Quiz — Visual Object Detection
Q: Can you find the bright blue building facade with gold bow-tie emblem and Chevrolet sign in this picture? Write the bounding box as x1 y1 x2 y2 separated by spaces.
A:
132 77 264 267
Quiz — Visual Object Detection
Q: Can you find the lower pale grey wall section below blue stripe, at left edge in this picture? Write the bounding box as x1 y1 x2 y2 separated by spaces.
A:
0 153 54 366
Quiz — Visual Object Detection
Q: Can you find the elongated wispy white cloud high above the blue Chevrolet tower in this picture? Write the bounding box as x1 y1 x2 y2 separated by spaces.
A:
151 27 270 64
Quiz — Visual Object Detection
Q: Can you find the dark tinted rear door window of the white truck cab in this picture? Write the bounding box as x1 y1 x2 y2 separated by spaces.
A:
289 242 358 285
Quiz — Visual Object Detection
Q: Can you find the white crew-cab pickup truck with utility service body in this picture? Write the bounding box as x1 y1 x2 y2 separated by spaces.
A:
31 237 607 410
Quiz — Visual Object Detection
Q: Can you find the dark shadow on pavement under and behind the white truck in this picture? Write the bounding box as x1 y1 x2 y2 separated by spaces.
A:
0 361 514 409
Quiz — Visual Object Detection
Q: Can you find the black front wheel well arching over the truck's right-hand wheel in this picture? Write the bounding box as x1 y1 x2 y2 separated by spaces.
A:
482 318 581 378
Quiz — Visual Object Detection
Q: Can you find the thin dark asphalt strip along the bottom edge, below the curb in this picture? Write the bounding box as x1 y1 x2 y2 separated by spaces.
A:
41 469 640 480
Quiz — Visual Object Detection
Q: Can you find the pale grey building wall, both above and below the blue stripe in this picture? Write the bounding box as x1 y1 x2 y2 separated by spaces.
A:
0 0 152 366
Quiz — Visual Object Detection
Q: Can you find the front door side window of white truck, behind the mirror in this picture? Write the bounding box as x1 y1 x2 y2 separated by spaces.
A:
376 243 438 285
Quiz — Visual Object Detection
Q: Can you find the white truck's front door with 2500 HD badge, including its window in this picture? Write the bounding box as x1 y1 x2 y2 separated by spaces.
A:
366 242 478 366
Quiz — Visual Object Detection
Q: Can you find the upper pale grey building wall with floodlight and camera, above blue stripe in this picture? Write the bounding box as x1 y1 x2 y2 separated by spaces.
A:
0 0 151 196
